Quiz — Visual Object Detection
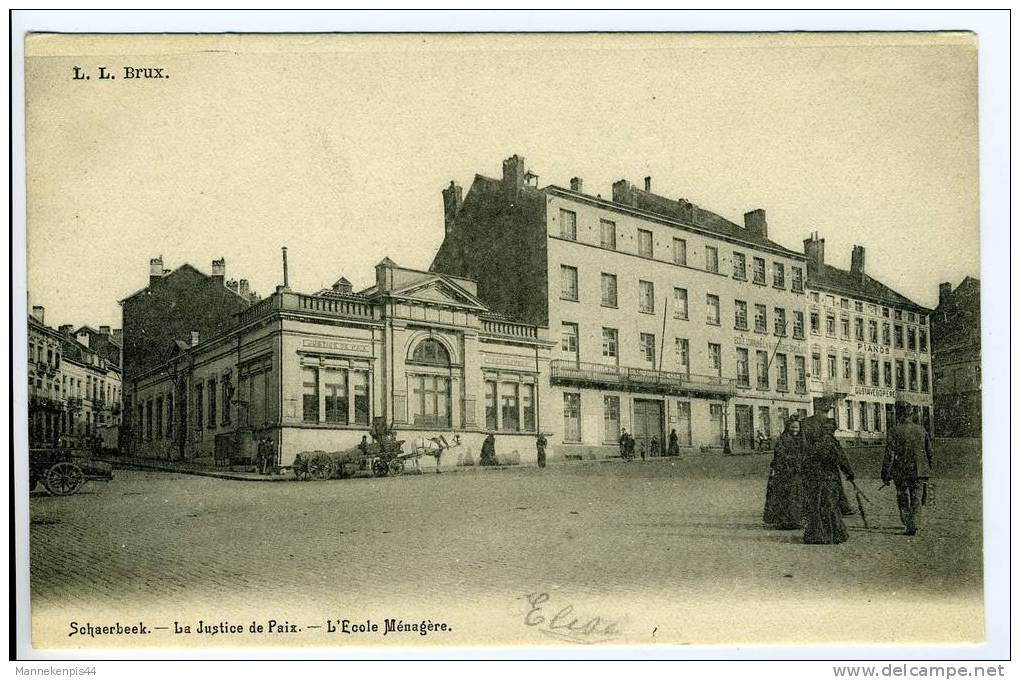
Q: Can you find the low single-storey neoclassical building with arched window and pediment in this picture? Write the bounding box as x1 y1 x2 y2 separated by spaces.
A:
131 259 551 466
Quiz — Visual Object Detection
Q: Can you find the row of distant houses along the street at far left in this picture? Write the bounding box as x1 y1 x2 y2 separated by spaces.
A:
29 307 121 449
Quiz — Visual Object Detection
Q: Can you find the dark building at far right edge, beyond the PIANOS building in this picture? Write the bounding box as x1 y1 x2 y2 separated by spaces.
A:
931 276 981 437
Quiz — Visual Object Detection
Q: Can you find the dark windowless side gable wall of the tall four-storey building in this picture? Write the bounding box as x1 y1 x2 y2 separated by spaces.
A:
431 178 549 325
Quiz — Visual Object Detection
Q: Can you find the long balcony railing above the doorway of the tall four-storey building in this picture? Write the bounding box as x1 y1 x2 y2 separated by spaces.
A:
550 360 736 398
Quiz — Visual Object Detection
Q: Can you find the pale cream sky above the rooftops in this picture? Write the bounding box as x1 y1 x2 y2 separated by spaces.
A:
26 34 980 327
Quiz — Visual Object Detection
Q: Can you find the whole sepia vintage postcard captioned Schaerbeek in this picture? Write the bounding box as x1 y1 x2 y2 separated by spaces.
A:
15 33 985 655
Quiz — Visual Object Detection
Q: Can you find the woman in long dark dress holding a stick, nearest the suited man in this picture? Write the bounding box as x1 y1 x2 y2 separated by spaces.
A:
804 421 854 544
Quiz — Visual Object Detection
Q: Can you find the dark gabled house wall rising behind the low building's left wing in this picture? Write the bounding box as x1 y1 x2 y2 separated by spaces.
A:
122 265 250 383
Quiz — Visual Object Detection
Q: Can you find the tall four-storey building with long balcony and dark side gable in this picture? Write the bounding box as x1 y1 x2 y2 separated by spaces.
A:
432 156 810 457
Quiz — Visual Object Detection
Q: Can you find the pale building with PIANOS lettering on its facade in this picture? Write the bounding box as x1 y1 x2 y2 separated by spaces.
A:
804 233 932 440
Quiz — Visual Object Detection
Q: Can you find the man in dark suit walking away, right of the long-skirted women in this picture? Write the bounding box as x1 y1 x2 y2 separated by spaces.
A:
882 404 932 536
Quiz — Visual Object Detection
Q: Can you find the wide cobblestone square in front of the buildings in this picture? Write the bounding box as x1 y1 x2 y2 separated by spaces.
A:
31 448 981 641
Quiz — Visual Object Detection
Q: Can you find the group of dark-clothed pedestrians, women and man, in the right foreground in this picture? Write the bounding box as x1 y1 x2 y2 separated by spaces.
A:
763 402 931 544
